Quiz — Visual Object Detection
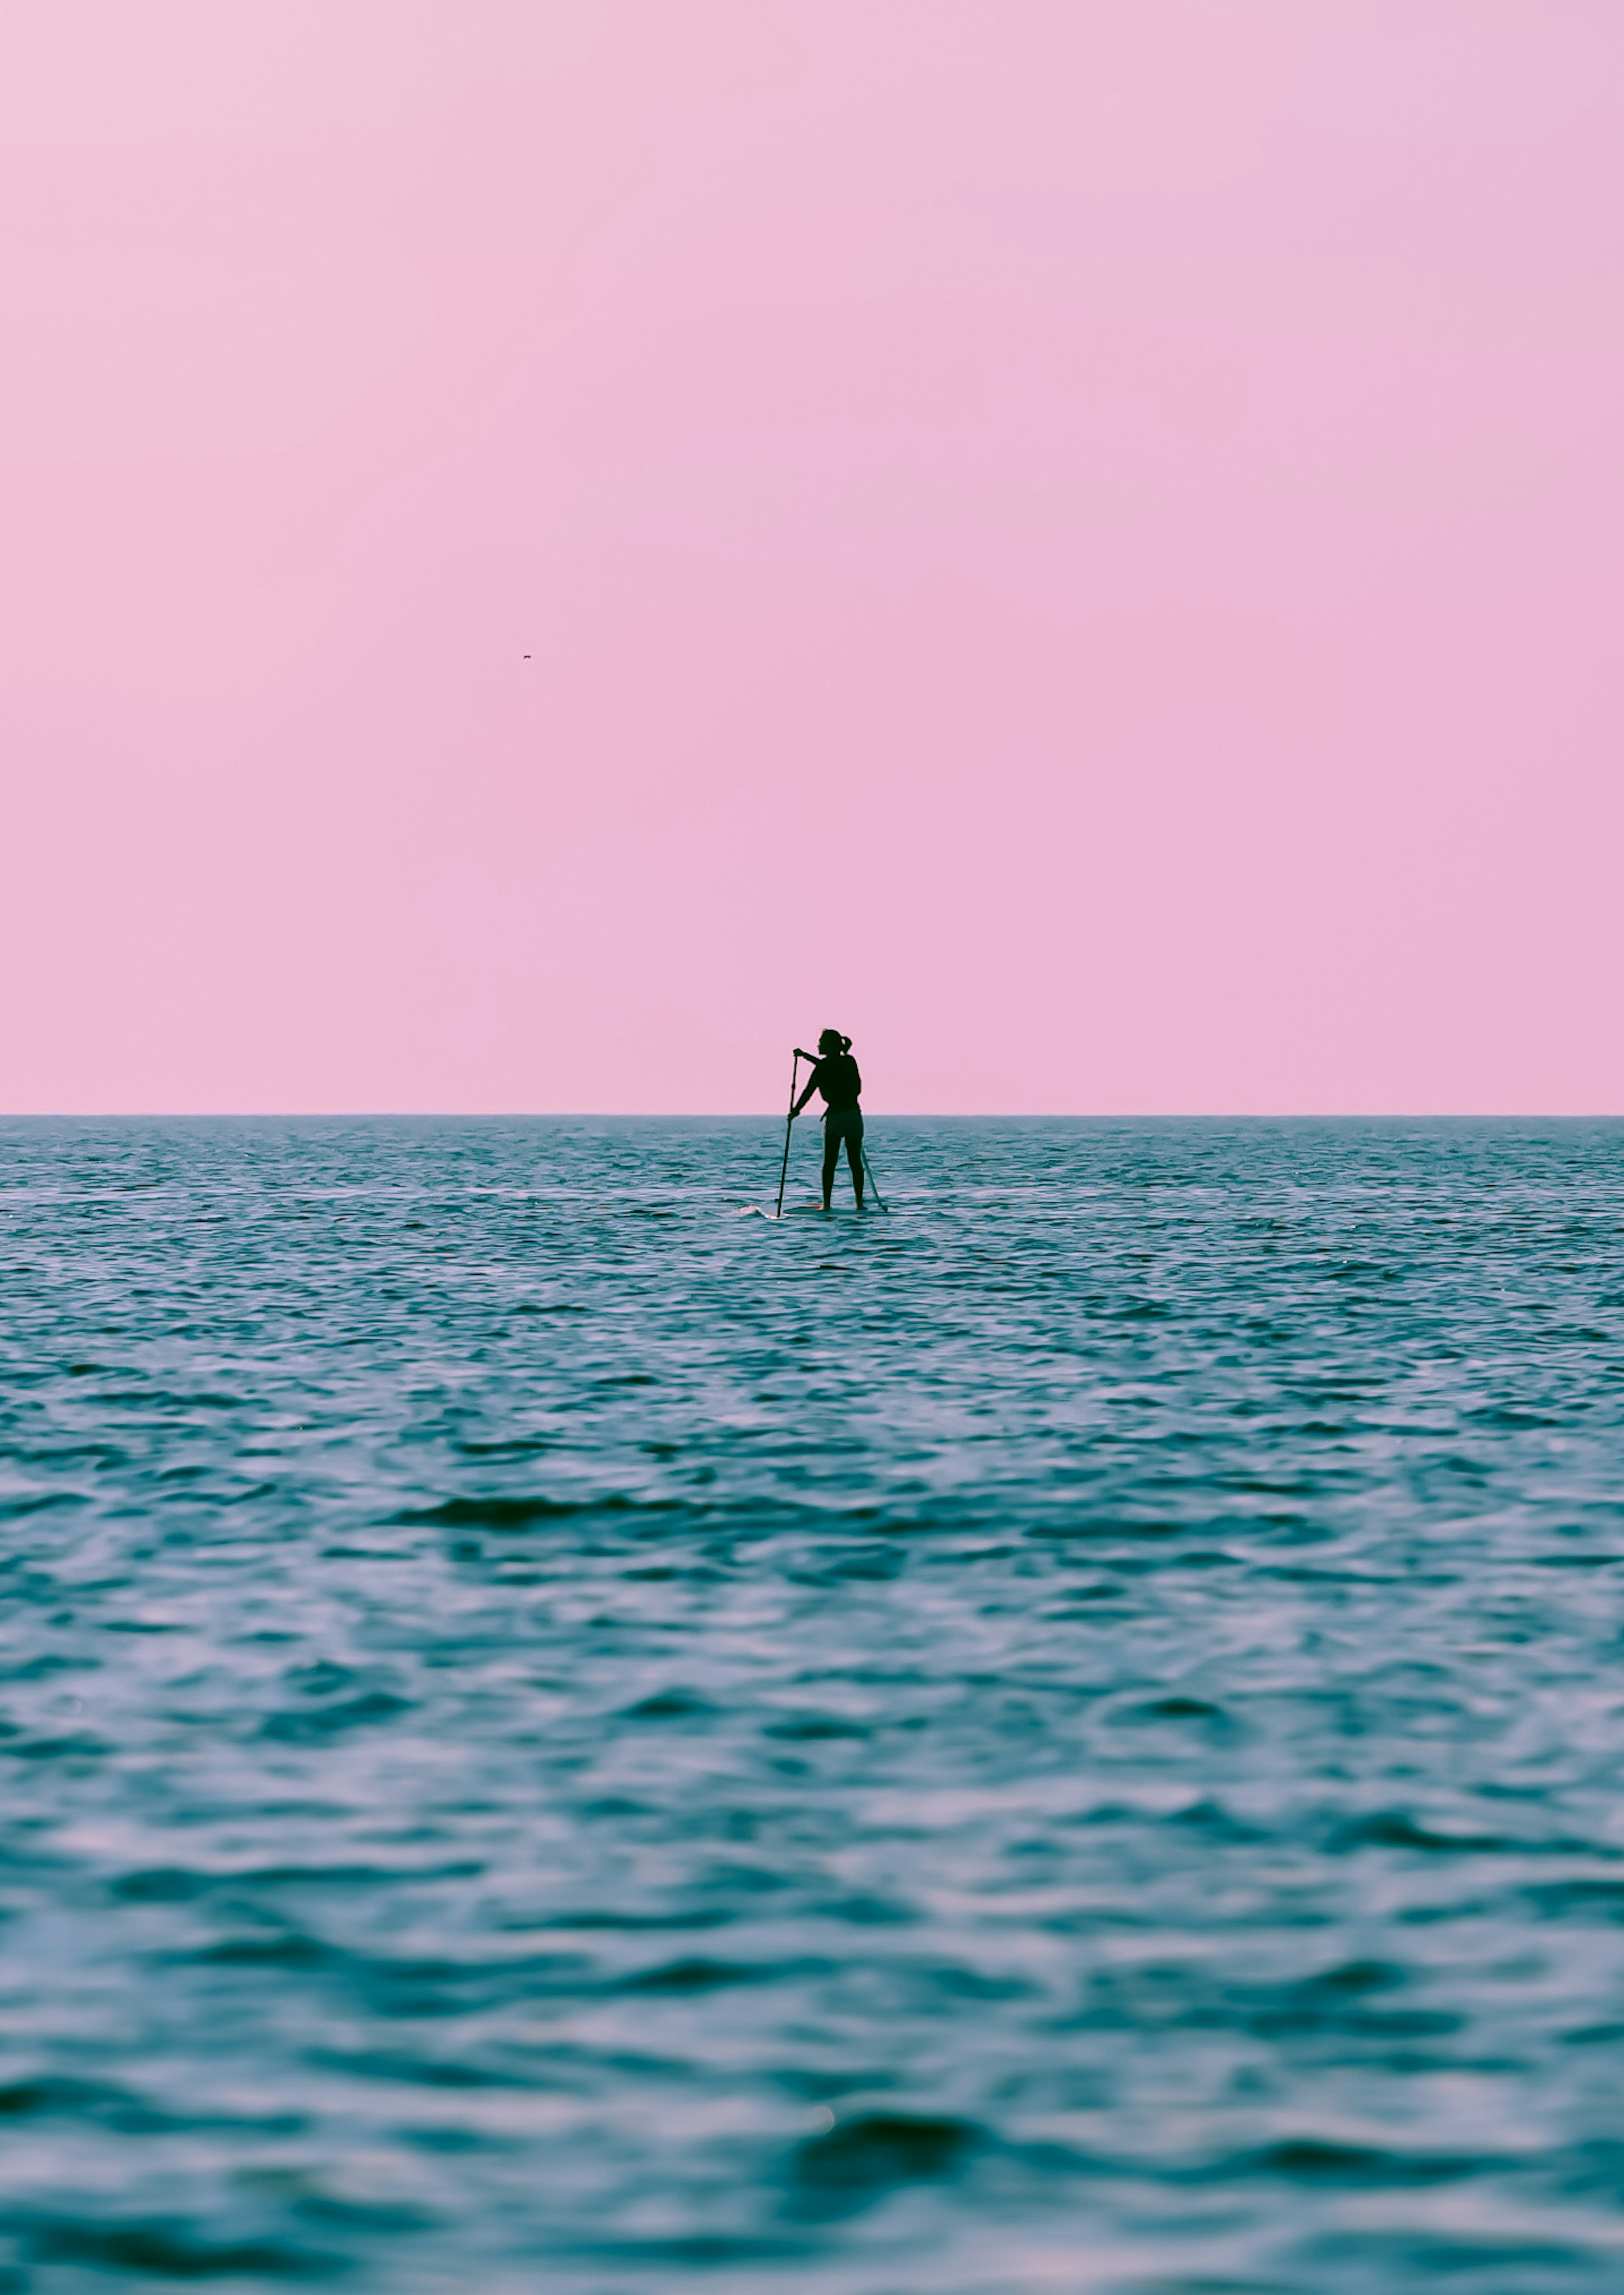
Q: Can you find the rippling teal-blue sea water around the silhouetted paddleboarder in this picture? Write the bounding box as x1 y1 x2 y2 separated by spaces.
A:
0 1120 1624 2295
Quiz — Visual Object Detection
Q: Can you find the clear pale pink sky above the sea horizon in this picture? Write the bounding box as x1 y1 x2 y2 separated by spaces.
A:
0 0 1624 1113
